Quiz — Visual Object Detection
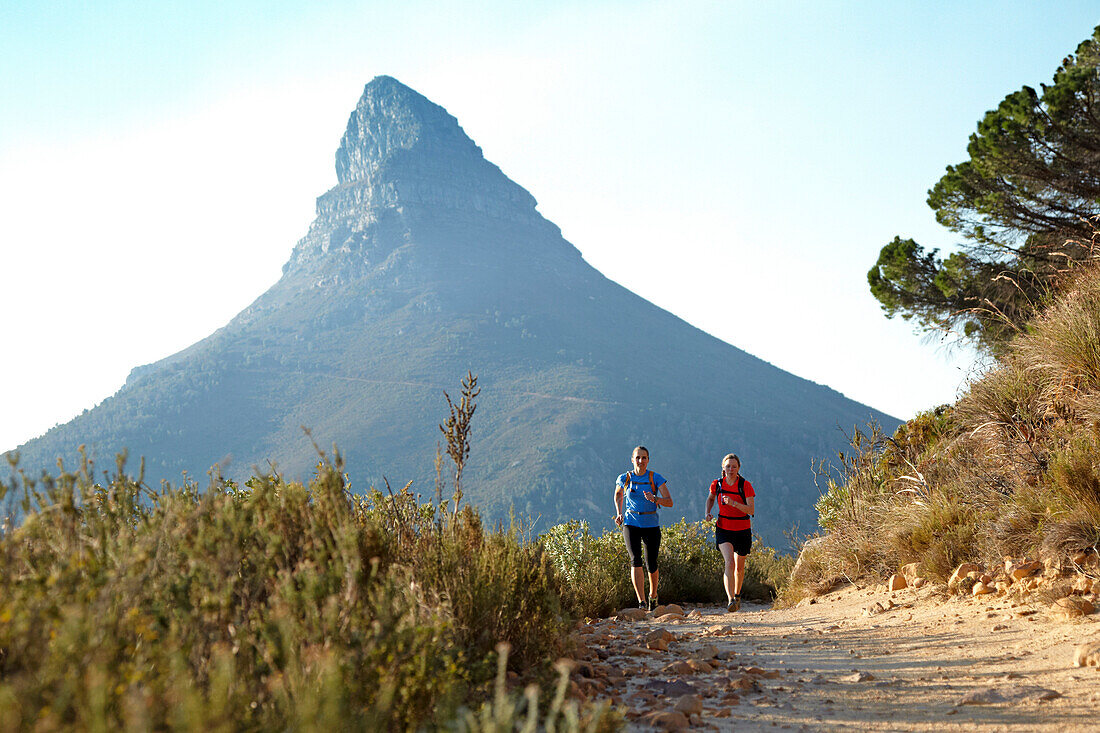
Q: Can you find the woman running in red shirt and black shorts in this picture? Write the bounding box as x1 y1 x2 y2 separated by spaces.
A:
706 453 756 612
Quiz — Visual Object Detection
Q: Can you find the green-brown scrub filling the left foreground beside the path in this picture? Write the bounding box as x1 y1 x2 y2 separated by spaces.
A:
0 457 614 731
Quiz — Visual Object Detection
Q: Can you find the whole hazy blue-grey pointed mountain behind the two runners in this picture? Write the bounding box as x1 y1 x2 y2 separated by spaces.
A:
10 77 898 543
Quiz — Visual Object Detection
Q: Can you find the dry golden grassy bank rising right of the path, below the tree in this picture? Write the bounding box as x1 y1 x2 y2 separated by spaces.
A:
782 266 1100 602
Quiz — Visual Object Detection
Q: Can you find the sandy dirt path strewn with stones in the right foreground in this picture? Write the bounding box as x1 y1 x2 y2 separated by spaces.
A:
573 586 1100 732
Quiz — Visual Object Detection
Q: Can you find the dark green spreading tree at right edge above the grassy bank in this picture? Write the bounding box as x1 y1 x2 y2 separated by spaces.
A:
868 26 1100 353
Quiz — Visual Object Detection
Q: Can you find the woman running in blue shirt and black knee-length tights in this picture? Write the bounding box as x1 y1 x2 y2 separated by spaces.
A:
615 446 672 611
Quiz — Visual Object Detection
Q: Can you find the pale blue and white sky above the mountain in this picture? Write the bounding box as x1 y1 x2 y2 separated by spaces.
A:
0 0 1100 450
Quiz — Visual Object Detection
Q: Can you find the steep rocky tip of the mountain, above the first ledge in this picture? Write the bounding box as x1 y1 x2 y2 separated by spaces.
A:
337 76 482 184
